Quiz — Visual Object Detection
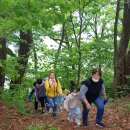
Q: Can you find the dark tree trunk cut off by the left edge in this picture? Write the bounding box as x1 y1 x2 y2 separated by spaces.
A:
0 38 7 87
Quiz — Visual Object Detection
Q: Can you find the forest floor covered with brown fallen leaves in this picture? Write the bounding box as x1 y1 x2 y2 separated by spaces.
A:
0 97 130 130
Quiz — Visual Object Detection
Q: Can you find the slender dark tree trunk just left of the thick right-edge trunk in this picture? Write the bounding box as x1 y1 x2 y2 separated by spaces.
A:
112 0 120 98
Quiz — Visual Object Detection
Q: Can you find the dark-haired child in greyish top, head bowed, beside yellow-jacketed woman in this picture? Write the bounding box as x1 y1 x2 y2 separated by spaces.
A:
35 78 46 113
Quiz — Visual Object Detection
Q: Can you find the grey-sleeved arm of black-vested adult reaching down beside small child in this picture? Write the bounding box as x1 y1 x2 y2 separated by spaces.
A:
79 84 91 109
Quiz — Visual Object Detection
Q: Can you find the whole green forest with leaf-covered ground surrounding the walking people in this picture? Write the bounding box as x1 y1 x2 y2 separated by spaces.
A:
0 0 130 130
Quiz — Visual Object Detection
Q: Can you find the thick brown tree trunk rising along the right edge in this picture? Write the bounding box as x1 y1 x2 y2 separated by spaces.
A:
116 0 130 85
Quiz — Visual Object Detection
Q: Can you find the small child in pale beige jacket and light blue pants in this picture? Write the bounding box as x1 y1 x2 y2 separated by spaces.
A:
64 86 81 126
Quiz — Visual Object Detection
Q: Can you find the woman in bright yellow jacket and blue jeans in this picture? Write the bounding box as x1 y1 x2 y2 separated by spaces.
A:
45 71 62 116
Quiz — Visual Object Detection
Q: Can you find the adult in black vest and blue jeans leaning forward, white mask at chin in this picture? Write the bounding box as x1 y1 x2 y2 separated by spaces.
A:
79 69 108 127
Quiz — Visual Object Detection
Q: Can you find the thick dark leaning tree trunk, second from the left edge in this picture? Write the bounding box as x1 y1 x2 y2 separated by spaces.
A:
11 30 33 84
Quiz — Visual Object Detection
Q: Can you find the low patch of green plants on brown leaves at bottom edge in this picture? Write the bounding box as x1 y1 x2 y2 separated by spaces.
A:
25 124 57 130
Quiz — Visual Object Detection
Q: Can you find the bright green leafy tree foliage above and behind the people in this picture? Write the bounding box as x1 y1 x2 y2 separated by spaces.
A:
0 0 123 97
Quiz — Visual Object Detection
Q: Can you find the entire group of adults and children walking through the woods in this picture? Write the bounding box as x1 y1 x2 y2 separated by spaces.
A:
28 68 108 127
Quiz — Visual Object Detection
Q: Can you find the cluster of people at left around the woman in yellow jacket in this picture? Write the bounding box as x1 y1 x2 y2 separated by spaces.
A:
28 71 69 116
